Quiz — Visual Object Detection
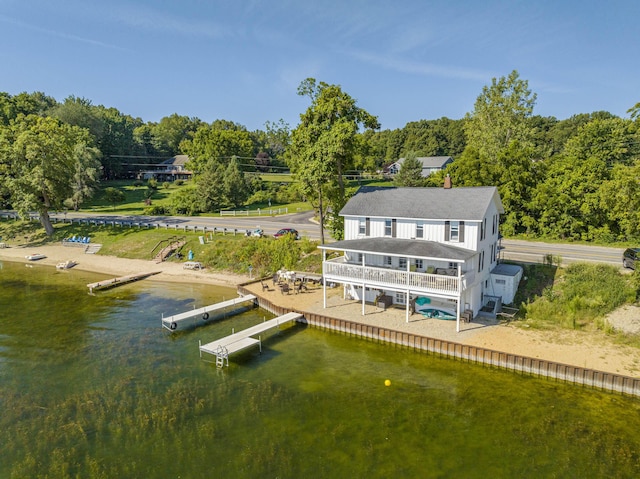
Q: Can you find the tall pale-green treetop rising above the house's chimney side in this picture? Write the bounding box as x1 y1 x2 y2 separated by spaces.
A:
465 70 536 158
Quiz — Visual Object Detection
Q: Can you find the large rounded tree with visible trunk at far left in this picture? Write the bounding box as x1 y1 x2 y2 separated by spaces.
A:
0 115 100 236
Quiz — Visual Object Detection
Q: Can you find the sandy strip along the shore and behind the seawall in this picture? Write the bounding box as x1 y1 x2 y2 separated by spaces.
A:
0 245 640 377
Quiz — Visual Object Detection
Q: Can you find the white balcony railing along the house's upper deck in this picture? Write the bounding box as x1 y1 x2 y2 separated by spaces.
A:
323 258 473 295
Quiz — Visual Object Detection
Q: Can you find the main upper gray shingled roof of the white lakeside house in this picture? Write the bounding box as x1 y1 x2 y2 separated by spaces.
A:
340 186 504 221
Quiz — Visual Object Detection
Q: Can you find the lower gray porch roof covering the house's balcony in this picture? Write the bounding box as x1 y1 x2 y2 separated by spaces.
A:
318 238 476 261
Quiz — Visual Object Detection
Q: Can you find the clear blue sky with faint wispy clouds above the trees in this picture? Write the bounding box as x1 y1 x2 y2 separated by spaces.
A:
0 0 640 130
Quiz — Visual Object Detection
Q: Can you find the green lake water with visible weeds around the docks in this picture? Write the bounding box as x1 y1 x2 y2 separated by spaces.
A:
0 262 640 479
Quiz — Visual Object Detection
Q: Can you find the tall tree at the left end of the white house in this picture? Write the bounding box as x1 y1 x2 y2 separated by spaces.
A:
287 78 380 244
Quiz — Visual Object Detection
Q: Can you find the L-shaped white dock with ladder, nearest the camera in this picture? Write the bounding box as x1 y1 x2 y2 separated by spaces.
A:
199 313 302 368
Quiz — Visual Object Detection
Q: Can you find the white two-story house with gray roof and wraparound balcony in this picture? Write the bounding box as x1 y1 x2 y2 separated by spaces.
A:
320 177 504 331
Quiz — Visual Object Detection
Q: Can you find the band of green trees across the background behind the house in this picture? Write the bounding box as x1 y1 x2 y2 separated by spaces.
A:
0 71 640 242
